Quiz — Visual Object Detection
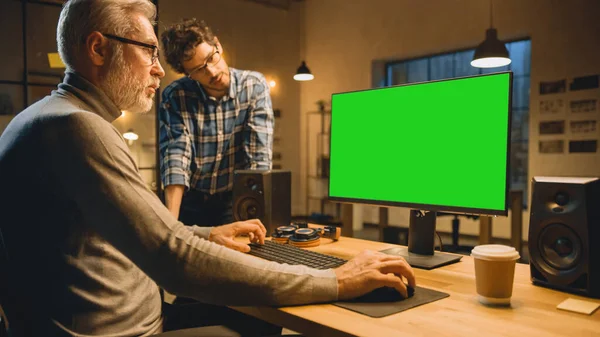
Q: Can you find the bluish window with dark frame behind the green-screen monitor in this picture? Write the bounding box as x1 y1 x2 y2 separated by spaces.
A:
380 40 531 207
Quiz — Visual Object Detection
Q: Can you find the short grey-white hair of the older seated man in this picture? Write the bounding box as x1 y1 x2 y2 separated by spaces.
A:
56 0 156 71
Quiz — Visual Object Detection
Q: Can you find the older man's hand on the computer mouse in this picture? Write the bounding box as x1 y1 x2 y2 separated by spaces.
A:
334 250 416 300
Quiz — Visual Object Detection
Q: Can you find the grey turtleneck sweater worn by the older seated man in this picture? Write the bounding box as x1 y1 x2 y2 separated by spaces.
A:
0 73 337 336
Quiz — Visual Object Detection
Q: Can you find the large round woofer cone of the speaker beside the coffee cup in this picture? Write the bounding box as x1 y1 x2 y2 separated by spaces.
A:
538 223 583 270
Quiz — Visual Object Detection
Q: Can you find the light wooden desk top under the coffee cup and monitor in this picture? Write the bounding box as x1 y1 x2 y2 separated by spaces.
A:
233 237 600 337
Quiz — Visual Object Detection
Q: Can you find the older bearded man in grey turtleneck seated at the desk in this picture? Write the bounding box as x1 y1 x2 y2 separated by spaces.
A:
0 0 414 336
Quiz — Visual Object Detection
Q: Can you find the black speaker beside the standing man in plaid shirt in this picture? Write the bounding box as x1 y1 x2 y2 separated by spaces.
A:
233 170 292 235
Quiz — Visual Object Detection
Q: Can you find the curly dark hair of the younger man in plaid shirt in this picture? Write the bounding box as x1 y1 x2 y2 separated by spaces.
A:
160 18 217 73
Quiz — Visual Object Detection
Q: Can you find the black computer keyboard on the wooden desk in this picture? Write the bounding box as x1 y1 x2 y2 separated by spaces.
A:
248 240 347 269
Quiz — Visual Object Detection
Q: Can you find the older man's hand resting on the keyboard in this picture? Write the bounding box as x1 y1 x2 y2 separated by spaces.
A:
208 219 267 253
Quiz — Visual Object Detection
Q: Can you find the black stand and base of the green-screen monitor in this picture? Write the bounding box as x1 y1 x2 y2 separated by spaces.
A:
381 210 462 269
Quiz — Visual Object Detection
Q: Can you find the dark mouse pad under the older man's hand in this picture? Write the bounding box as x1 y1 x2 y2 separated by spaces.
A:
332 286 450 318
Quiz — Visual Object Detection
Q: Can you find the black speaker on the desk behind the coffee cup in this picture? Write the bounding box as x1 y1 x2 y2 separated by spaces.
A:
528 177 600 297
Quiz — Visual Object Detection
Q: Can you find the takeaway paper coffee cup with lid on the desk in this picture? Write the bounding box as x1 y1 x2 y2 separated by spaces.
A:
471 245 520 305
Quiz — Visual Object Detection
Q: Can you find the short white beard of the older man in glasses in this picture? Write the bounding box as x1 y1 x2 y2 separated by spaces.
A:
100 52 158 113
